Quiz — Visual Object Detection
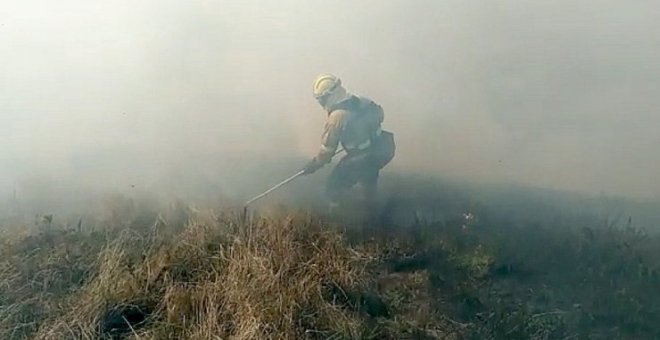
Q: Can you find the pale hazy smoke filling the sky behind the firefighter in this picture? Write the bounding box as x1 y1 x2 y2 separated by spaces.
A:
0 0 660 202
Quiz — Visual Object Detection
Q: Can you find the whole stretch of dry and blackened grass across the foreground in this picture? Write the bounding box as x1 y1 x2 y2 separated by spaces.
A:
0 189 660 339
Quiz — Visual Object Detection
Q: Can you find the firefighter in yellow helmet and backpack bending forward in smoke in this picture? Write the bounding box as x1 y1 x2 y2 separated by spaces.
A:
303 74 396 209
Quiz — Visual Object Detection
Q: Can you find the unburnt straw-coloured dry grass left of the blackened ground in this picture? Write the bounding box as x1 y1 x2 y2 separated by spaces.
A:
0 199 458 339
